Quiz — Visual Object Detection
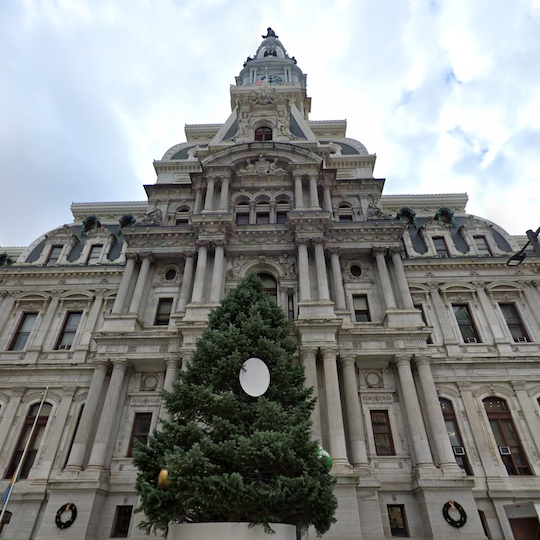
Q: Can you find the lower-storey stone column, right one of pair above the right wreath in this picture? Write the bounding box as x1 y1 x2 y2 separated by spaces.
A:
415 356 463 476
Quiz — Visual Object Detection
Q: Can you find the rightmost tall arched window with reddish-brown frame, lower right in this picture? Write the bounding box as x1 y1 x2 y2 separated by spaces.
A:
483 397 531 475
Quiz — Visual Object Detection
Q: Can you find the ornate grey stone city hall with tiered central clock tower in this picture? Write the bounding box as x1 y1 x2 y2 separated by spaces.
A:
0 29 540 540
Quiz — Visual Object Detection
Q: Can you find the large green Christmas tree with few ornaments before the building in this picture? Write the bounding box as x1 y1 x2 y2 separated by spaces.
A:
134 275 337 535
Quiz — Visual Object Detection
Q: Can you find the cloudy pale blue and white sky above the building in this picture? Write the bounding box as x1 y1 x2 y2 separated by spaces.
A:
0 0 540 246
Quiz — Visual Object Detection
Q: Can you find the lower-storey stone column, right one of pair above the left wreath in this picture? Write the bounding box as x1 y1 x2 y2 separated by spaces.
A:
87 360 128 469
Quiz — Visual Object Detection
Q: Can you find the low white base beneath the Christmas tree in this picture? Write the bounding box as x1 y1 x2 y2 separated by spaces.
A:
167 522 296 540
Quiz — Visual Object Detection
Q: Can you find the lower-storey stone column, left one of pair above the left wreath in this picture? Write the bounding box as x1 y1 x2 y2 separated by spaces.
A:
66 360 109 471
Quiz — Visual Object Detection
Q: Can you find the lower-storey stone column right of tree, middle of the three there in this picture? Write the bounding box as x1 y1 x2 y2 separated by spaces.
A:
322 349 350 468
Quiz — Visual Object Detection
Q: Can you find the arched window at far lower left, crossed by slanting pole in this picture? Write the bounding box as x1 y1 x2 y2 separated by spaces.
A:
4 403 52 478
